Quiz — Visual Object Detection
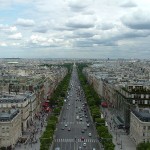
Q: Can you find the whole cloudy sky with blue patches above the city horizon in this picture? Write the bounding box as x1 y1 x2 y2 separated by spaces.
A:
0 0 150 59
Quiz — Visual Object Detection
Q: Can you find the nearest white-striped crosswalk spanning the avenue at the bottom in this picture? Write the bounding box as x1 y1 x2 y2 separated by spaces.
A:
54 139 99 143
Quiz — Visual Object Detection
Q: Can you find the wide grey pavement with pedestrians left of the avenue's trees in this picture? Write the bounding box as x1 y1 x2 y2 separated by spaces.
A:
14 114 47 150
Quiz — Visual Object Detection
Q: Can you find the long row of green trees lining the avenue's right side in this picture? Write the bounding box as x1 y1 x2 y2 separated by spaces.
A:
77 64 115 150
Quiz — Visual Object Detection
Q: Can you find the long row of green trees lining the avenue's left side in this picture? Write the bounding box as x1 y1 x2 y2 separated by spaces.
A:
40 64 72 150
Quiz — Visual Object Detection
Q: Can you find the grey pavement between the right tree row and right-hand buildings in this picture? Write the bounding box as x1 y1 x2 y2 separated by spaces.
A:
102 108 136 150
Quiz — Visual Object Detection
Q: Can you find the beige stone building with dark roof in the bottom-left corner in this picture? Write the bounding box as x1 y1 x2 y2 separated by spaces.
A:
0 109 22 147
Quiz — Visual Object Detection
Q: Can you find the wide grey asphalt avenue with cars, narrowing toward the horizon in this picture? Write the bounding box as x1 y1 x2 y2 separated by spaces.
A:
53 66 101 150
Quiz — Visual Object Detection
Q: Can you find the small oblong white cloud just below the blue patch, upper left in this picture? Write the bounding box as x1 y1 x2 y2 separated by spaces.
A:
16 18 35 27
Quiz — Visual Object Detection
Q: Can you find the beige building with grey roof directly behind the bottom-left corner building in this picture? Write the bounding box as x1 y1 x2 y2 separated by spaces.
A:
0 93 38 131
